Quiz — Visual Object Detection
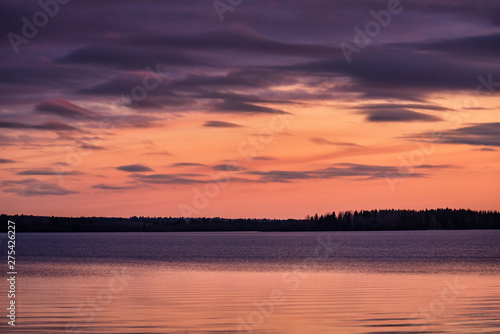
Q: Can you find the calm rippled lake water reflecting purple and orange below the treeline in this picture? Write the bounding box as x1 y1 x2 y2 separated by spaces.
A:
0 231 500 333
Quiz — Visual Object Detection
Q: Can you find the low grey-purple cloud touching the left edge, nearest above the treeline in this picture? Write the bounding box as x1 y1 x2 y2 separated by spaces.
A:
2 178 77 196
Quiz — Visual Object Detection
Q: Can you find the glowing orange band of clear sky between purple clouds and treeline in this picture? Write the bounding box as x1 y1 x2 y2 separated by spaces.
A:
1 95 500 218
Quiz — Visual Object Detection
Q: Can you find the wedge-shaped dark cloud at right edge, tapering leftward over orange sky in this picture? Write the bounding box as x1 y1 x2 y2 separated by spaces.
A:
405 122 500 147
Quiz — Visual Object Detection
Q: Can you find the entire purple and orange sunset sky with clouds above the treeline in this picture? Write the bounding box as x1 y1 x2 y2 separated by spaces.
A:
0 0 500 218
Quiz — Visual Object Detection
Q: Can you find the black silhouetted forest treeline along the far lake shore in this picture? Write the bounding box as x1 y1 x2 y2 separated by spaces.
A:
0 209 500 232
